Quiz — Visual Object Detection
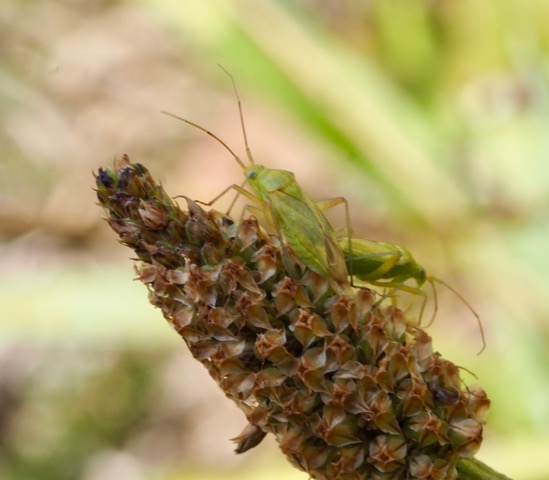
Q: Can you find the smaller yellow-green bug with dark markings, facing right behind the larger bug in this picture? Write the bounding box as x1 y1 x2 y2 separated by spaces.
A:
340 238 486 354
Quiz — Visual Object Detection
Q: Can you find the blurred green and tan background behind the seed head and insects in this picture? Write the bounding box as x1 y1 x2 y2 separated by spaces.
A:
0 0 549 480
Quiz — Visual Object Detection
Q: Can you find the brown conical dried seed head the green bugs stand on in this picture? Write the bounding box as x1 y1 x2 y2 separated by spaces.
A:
96 157 490 480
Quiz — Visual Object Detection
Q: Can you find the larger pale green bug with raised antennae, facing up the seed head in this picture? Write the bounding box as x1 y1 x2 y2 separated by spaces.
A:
162 69 351 285
